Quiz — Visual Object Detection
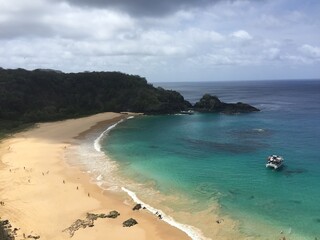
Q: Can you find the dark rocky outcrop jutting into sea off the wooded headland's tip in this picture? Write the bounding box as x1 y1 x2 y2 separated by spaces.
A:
194 94 260 114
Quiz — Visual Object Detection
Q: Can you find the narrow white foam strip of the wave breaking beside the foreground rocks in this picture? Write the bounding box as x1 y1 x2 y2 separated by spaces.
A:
121 187 210 240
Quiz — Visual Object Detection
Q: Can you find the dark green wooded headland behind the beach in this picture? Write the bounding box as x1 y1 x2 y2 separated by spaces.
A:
0 68 191 135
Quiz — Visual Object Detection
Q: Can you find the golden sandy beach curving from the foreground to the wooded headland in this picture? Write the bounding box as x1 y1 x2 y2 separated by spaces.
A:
0 113 190 240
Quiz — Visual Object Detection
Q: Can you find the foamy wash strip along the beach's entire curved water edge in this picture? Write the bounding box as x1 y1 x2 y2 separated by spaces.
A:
66 115 210 240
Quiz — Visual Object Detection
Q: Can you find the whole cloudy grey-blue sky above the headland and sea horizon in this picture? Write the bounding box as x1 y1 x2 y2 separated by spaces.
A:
0 0 320 82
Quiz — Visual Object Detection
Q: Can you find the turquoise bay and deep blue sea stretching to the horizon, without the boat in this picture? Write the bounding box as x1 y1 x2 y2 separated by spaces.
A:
103 81 320 239
